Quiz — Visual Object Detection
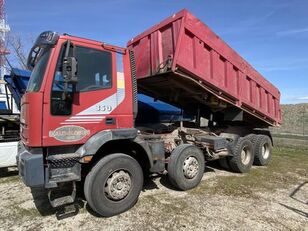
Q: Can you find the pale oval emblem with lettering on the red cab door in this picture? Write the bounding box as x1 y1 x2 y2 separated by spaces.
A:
49 125 90 142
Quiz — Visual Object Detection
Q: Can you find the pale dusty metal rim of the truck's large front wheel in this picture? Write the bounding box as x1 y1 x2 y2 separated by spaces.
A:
105 170 132 201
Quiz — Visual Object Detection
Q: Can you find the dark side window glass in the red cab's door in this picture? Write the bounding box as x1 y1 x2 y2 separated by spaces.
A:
51 45 112 115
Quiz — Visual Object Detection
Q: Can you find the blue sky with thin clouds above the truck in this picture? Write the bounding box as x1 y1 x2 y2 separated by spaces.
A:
5 0 308 104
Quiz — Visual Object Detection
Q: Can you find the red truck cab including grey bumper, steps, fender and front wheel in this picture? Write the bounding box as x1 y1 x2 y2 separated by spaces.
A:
17 31 164 216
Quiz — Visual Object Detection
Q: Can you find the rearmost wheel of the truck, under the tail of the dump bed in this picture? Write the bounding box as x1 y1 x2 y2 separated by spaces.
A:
254 135 273 166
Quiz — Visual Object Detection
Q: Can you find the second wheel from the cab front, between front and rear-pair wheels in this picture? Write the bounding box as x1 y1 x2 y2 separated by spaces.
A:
168 144 205 191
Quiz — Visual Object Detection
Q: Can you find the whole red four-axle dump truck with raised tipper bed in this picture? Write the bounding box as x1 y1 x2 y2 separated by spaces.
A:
17 10 281 216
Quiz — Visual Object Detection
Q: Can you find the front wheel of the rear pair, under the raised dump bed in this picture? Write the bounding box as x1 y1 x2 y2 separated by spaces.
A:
229 137 254 173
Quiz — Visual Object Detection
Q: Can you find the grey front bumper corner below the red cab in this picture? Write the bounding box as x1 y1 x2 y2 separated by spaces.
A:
17 144 44 187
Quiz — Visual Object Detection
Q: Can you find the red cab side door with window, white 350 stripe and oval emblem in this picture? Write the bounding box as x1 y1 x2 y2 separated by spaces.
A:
43 38 133 146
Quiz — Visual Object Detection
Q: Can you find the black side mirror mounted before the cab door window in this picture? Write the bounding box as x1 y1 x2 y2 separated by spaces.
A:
62 56 78 84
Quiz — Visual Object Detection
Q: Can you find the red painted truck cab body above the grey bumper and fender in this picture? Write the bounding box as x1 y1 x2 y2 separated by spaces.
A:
21 32 133 148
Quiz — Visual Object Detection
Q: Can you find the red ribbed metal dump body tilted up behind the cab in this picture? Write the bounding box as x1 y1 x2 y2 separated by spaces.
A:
128 10 281 125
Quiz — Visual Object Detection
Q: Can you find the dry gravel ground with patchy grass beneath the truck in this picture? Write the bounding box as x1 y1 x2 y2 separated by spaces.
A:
0 148 308 230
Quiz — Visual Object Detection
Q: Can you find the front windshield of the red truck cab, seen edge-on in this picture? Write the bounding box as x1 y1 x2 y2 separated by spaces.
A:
27 48 51 92
